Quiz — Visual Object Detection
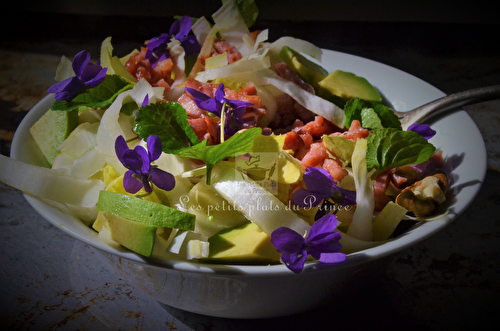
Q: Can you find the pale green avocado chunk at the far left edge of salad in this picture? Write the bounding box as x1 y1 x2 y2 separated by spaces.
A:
30 110 78 166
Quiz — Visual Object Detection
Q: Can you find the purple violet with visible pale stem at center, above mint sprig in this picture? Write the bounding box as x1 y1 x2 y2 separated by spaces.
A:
186 84 253 136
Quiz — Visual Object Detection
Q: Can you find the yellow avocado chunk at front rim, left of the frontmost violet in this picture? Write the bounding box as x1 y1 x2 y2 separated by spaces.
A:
204 222 281 264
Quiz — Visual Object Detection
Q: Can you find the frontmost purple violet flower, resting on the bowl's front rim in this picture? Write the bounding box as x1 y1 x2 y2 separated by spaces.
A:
271 214 346 274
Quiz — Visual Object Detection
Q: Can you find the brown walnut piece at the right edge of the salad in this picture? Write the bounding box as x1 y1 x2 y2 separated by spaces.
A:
396 170 449 218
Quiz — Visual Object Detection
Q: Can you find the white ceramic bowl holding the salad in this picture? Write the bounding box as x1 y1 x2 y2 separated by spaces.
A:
11 50 486 318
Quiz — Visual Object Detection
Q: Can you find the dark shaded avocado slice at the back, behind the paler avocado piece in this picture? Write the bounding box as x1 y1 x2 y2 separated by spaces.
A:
279 46 328 90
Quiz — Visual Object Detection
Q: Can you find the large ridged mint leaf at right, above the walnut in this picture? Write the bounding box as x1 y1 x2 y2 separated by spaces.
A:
366 128 436 178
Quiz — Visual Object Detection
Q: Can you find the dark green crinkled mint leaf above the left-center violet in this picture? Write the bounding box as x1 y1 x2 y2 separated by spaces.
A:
134 101 200 154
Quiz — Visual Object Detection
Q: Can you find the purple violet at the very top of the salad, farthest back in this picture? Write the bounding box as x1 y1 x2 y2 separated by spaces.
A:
146 16 201 67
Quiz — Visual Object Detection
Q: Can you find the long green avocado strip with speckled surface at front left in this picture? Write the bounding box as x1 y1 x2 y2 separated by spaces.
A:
97 191 196 231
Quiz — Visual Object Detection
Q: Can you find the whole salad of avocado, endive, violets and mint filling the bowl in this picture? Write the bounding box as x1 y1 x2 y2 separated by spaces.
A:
0 0 451 274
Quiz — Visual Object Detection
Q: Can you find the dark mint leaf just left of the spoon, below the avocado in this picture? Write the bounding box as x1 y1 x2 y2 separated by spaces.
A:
344 98 402 130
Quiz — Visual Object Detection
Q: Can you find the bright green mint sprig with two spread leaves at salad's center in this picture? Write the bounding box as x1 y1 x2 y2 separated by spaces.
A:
178 128 262 185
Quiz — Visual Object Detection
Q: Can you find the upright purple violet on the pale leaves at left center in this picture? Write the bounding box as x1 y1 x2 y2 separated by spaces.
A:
115 136 175 194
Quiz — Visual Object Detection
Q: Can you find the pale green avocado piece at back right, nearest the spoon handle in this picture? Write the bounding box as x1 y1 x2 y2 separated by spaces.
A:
318 70 382 103
